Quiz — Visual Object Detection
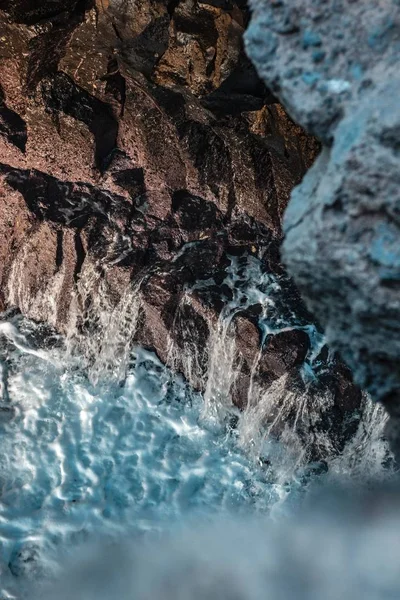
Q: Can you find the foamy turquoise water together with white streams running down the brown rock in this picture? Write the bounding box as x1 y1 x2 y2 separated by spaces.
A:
0 252 394 600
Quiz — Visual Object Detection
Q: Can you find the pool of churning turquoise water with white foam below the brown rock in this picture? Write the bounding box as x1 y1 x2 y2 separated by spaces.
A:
0 327 274 594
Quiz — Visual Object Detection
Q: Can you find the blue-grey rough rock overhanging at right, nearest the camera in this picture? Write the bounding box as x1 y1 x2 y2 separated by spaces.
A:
246 0 400 448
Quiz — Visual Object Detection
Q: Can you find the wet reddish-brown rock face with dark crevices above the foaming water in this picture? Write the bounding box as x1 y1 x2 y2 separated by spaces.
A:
0 0 361 460
